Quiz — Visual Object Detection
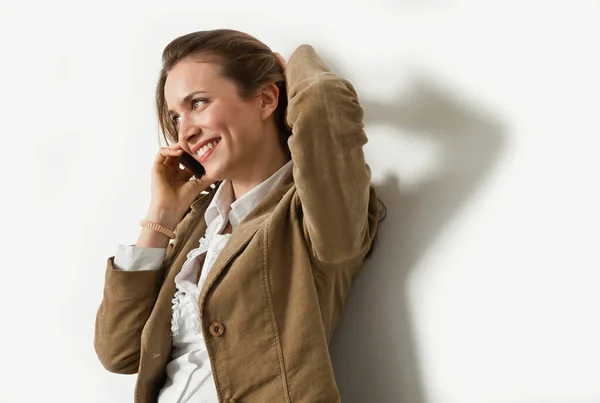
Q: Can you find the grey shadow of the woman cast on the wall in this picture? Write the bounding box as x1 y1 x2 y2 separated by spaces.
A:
331 70 504 403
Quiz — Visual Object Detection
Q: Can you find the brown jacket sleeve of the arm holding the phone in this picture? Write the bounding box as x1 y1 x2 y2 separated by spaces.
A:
94 240 173 374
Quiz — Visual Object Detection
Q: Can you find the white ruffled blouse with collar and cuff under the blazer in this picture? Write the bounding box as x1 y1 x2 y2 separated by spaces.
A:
114 161 292 403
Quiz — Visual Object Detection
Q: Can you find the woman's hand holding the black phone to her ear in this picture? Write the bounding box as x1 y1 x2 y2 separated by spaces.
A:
150 143 215 224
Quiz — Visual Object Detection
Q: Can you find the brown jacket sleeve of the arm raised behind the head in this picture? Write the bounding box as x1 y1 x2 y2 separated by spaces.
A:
286 45 377 263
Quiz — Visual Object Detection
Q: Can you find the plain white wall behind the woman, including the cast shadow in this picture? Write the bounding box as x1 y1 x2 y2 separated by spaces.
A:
0 0 600 403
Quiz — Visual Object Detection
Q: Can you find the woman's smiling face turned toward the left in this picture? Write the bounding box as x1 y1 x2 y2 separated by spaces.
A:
164 59 265 180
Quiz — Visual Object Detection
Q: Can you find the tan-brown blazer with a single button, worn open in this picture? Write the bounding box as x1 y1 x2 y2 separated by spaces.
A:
94 45 378 403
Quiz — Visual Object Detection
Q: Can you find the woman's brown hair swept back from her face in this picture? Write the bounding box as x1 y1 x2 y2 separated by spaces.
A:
156 29 291 154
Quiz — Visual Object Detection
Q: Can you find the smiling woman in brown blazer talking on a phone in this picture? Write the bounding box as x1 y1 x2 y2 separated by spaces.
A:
95 30 378 403
